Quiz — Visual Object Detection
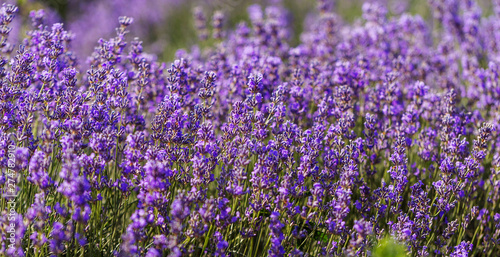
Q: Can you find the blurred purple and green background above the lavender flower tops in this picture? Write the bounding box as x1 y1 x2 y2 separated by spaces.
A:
6 0 492 61
